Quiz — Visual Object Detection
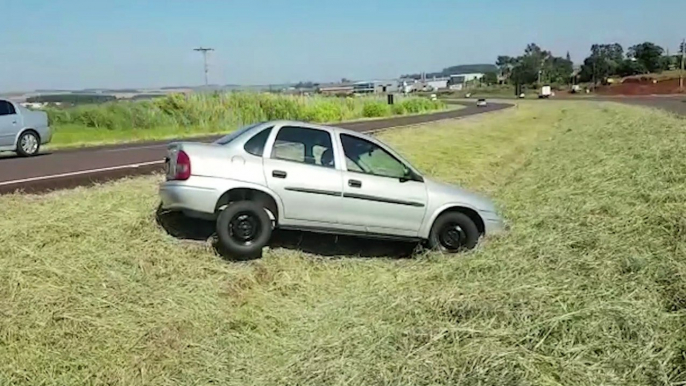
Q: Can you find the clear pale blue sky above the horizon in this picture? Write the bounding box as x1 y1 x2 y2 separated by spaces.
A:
0 0 686 92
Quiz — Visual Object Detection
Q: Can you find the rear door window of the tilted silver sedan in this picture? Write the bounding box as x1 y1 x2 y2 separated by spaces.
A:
271 126 335 168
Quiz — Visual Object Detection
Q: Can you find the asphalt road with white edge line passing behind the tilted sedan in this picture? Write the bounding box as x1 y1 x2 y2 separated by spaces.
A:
0 102 512 194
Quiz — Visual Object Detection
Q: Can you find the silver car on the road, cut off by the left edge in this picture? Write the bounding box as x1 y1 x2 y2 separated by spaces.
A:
0 99 52 157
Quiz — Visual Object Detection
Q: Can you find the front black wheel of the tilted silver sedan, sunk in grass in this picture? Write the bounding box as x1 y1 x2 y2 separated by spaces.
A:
428 212 481 253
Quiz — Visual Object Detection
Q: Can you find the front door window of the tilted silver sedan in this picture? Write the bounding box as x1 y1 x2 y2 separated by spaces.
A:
341 134 409 178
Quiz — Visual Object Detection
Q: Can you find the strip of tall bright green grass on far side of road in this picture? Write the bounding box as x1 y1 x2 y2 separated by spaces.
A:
48 93 445 148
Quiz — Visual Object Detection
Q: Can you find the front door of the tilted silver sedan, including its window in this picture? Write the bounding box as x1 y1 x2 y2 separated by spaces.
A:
339 133 427 237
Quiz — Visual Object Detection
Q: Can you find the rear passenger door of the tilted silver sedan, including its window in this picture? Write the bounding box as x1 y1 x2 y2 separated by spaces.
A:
263 126 343 227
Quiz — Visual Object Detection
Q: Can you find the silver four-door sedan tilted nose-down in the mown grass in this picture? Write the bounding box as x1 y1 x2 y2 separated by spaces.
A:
159 121 504 258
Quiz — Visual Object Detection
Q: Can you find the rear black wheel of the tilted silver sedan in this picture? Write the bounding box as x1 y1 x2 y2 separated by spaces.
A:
217 201 272 259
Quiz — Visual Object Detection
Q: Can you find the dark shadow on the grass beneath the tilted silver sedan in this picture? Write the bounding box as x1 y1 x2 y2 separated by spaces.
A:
155 207 417 260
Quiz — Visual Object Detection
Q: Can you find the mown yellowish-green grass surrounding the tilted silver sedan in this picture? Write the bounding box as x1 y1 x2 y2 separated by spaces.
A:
0 101 686 385
